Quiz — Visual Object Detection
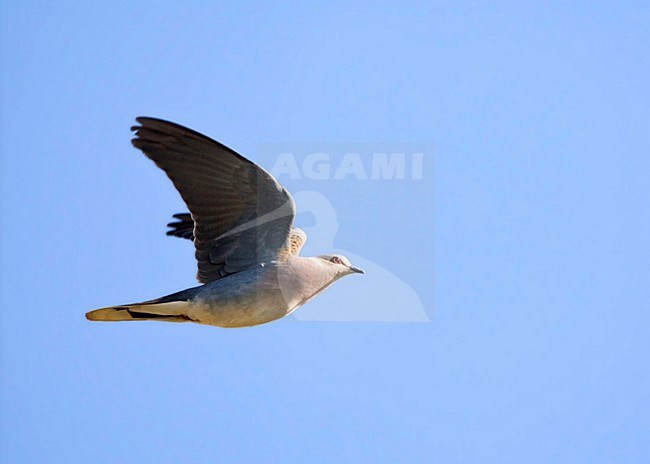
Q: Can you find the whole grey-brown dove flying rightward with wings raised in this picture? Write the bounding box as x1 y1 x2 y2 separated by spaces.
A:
86 117 364 327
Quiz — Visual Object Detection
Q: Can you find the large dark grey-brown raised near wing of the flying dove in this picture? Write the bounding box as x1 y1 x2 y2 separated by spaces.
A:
131 117 295 283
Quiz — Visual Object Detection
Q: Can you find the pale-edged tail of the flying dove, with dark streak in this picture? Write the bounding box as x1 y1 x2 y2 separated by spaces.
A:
86 300 191 322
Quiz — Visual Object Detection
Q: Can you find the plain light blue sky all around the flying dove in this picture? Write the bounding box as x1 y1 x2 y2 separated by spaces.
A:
0 1 650 464
